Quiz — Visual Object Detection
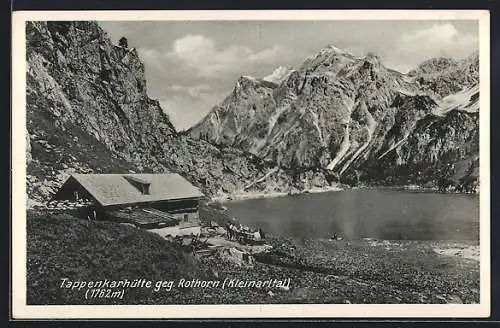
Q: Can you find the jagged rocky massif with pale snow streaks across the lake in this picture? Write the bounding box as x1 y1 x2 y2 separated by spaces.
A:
189 46 479 189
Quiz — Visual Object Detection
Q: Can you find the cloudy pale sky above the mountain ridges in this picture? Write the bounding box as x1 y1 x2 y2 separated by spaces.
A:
99 20 479 130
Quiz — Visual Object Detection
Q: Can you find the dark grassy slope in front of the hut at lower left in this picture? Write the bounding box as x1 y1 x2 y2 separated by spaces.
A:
27 211 211 304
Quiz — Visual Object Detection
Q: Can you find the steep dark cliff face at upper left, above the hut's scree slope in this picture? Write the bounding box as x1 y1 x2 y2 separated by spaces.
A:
26 22 175 160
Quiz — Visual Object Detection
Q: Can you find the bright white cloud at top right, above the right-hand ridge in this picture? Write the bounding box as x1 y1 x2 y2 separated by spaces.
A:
386 23 478 72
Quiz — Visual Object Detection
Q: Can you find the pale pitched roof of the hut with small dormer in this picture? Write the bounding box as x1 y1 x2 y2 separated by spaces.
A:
67 173 203 206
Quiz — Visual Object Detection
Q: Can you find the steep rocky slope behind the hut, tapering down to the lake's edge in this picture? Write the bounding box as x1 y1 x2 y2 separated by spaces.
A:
26 22 308 202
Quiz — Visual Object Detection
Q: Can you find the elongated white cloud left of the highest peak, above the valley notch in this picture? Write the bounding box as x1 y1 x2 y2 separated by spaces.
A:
165 35 283 78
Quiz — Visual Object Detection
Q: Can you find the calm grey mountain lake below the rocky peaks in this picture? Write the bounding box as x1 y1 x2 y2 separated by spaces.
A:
224 189 479 240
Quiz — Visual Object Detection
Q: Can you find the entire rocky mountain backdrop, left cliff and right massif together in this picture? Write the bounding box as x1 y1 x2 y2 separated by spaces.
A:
26 22 479 202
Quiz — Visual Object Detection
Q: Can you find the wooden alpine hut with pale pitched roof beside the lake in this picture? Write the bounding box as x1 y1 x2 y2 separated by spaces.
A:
52 173 204 228
